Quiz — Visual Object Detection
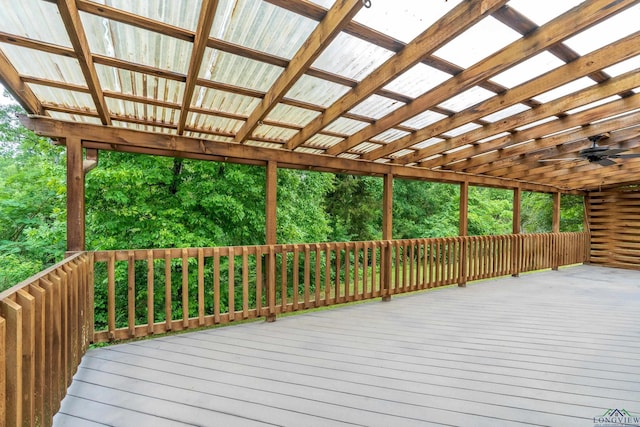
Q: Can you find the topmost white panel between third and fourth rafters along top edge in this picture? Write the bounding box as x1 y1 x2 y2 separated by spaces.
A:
355 0 462 43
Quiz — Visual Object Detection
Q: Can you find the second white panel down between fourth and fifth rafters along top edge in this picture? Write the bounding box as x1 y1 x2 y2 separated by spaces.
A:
434 16 522 68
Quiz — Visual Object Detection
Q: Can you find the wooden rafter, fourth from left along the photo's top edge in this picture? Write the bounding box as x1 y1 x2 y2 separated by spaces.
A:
287 0 506 154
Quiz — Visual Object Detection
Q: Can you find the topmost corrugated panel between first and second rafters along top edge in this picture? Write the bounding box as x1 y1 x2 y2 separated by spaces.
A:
91 0 202 31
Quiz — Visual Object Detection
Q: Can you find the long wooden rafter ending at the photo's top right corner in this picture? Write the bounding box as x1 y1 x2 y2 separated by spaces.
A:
360 0 634 161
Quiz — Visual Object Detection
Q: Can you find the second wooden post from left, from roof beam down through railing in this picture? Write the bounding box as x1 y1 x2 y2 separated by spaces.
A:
264 161 278 322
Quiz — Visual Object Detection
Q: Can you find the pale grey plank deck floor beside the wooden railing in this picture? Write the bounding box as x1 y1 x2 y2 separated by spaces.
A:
54 266 640 427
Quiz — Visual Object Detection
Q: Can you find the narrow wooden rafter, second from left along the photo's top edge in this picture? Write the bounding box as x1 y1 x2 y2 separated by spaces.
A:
178 0 218 135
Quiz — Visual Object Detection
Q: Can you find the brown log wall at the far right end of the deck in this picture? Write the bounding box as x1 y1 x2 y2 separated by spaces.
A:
585 189 640 270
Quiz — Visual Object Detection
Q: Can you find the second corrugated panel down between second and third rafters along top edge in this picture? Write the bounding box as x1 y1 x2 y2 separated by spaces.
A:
199 48 283 92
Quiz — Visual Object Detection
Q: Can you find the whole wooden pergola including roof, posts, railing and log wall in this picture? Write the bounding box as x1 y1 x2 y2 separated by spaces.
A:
0 0 640 424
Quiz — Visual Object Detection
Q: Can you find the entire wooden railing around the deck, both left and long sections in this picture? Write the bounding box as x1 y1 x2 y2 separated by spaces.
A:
0 233 589 426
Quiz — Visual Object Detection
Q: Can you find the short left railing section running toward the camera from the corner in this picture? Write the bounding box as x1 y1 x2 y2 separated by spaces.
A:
0 253 93 426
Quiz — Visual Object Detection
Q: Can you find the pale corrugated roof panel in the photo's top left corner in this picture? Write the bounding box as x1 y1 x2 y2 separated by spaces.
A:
0 0 71 47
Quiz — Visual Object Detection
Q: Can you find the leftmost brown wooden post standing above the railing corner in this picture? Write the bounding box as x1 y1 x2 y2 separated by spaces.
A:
66 137 85 252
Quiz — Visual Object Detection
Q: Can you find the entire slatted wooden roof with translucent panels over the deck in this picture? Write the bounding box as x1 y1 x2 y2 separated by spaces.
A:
0 0 640 190
